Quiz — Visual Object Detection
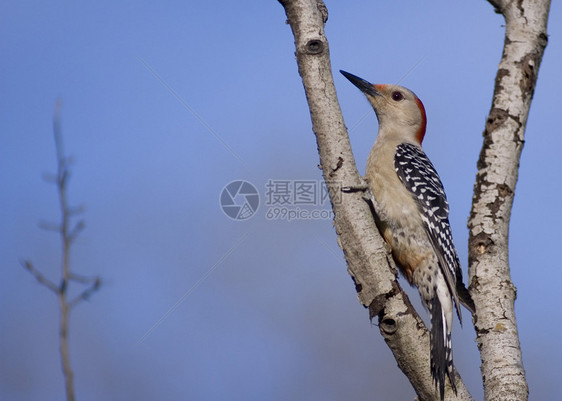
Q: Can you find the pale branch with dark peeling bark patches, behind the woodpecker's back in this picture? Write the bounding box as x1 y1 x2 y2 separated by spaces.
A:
468 0 550 401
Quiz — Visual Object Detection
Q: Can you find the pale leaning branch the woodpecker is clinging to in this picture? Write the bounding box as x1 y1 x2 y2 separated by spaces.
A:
280 0 472 400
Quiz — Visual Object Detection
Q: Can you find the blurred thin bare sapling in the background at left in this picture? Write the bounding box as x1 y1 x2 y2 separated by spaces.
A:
22 100 101 401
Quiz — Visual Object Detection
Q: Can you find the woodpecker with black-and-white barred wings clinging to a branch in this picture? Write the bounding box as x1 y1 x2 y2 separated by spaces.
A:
340 71 474 400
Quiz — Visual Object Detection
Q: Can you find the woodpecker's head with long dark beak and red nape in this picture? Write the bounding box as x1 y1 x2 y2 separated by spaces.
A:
340 70 427 145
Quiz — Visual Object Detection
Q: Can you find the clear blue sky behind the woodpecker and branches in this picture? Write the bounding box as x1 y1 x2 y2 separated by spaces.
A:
0 0 562 401
